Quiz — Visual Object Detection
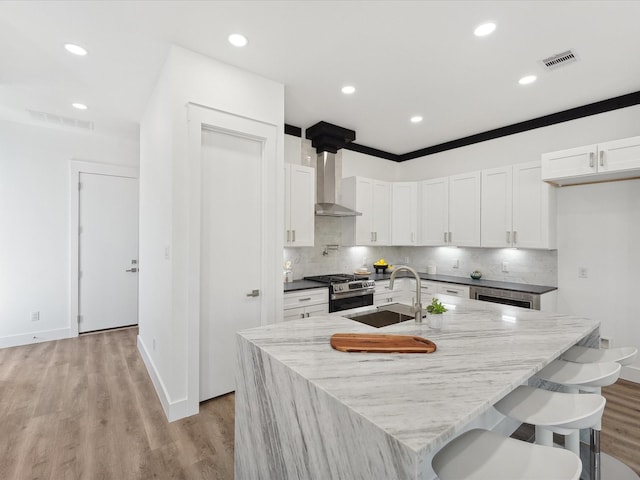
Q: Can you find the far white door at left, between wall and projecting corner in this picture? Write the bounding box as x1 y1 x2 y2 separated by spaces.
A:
78 173 138 332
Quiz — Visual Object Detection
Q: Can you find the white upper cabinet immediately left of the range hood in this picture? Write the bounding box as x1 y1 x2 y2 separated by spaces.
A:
284 164 316 247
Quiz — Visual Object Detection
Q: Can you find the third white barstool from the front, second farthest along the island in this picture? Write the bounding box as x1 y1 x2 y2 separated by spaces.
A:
536 360 622 480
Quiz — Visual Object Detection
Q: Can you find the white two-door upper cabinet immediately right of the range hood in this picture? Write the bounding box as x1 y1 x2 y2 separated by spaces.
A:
342 177 391 245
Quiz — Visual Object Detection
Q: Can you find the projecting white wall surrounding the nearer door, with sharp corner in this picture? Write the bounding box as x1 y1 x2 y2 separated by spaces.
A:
139 47 284 420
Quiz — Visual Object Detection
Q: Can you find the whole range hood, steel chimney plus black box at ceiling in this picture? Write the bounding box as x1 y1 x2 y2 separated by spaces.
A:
305 122 362 217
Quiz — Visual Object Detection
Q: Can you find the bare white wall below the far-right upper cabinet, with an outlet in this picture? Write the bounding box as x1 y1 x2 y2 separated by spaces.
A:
558 180 640 382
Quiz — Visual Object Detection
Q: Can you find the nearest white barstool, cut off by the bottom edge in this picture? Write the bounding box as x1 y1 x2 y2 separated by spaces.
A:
431 429 582 480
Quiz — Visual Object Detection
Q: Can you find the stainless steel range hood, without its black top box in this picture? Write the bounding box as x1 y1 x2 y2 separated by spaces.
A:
316 152 362 217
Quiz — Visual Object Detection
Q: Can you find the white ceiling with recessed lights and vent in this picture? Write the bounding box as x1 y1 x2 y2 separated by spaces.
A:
0 1 640 154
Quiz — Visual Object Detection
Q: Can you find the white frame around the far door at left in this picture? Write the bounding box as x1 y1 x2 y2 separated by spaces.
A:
69 159 140 337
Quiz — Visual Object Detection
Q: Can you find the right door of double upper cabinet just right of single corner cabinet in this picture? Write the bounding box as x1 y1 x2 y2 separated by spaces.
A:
447 172 480 247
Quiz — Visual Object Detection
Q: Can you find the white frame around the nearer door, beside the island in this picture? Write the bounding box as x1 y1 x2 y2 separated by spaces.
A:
185 102 284 415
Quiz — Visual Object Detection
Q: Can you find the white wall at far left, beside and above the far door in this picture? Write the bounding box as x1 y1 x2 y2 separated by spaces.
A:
0 121 138 347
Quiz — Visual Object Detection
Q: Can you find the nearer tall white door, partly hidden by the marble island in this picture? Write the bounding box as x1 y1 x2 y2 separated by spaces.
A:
200 129 264 401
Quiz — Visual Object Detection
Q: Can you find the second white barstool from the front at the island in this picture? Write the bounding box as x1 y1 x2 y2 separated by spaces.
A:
494 385 607 456
